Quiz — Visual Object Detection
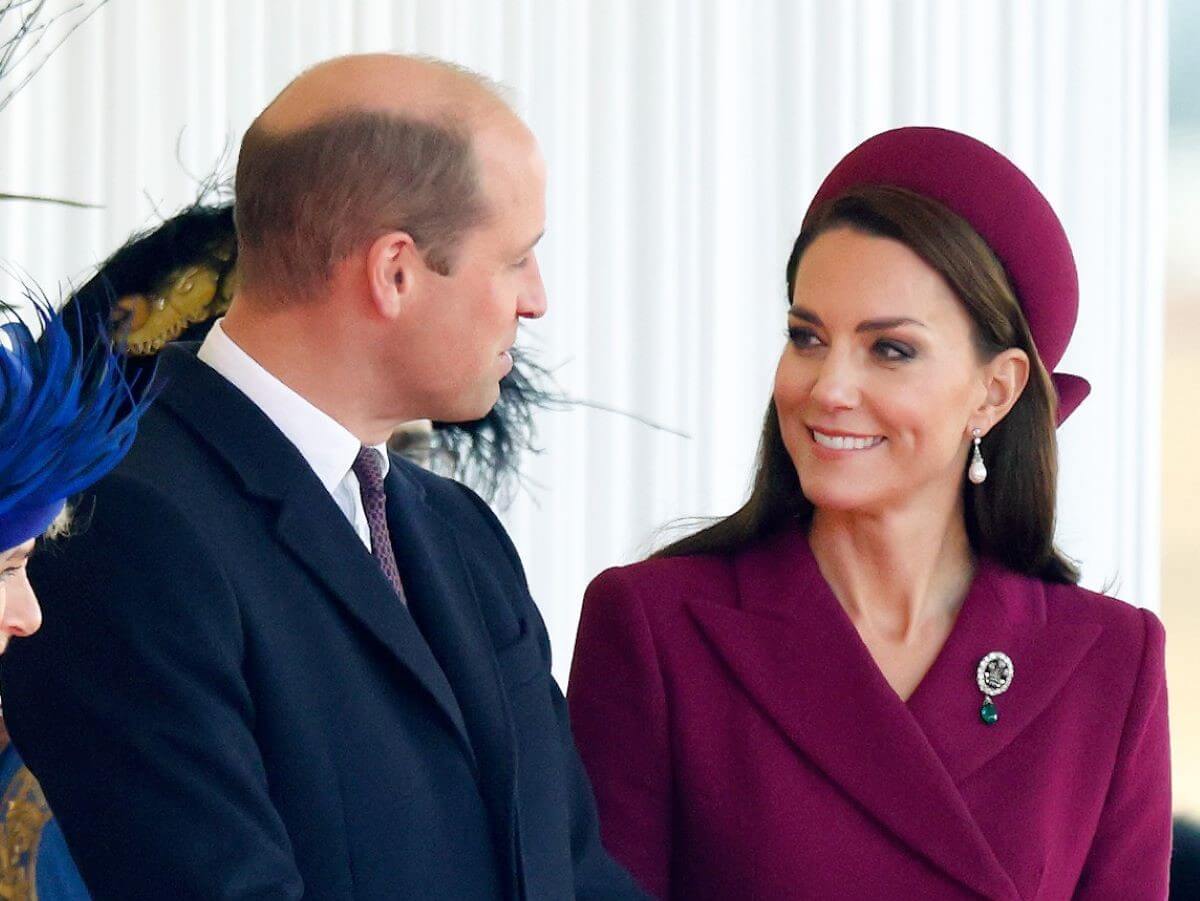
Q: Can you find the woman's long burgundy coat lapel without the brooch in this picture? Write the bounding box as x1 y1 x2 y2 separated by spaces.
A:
690 533 1018 899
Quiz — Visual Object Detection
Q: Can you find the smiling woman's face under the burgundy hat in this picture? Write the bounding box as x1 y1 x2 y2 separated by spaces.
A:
775 228 993 513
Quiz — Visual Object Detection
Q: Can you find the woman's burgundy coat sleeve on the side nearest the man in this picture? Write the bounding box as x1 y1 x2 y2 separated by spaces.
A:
568 570 672 897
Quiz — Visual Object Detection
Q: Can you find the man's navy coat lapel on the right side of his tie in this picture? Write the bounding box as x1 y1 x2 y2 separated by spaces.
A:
384 459 520 894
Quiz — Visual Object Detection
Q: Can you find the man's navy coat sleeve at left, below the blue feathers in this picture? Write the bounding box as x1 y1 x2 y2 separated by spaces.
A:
2 476 304 901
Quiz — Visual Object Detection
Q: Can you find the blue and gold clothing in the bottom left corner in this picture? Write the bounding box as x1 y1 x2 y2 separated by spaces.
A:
0 744 89 901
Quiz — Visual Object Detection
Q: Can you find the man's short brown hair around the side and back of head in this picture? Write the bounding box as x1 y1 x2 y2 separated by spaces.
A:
234 110 487 296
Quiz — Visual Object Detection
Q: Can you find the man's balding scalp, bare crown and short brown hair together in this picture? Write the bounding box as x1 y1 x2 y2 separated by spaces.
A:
235 54 524 300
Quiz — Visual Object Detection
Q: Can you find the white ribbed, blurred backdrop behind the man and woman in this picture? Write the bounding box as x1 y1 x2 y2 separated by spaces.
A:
0 0 1200 815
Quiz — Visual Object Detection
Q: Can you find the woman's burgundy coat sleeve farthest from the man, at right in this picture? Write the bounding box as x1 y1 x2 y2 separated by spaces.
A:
1075 611 1171 901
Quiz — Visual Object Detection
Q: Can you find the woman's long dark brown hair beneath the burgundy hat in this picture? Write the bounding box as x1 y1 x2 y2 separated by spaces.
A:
654 186 1079 584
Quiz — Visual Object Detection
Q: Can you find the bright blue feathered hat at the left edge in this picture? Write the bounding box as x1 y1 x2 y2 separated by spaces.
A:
0 289 151 552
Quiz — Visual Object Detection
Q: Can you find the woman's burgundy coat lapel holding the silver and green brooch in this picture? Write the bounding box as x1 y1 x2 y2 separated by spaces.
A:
908 560 1100 782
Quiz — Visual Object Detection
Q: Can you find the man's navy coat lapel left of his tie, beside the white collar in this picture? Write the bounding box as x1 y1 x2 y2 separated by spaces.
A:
157 346 474 761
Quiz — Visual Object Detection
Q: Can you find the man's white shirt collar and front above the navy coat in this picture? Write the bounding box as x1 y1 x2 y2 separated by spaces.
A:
197 319 389 551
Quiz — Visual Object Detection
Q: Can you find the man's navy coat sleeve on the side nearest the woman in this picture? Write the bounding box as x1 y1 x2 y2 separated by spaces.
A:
457 485 646 901
